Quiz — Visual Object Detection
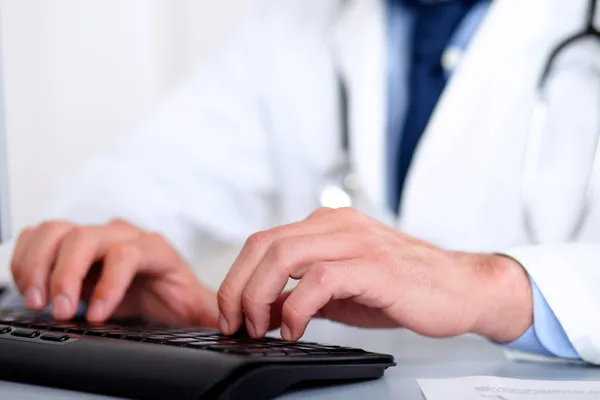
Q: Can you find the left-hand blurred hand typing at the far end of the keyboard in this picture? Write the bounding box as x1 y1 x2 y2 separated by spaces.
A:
11 220 218 328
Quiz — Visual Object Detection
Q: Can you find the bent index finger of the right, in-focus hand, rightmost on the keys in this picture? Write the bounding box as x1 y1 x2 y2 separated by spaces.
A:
281 262 368 341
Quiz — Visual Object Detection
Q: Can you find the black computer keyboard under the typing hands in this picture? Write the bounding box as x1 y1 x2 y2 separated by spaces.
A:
0 310 394 399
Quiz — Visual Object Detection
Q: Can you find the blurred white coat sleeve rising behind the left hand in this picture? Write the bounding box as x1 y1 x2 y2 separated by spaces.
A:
22 3 275 266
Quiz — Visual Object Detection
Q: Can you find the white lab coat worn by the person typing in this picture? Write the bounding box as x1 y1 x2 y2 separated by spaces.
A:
3 0 600 363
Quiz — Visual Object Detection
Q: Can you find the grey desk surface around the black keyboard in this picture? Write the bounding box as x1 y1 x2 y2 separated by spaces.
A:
0 321 600 400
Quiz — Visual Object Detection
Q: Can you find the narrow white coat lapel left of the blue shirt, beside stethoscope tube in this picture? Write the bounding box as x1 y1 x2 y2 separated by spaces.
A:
332 0 387 209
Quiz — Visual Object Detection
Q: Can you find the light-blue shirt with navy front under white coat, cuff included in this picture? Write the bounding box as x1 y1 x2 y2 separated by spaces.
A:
386 0 579 359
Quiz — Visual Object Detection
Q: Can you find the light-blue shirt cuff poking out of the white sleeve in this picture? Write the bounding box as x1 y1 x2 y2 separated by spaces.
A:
506 277 581 360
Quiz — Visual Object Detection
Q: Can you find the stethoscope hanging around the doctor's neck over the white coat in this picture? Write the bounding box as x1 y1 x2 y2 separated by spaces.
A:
320 0 600 244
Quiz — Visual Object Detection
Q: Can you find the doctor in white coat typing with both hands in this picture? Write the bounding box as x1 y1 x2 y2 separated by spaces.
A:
4 0 600 363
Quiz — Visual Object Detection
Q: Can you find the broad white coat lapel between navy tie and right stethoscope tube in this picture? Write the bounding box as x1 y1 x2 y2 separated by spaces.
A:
400 0 584 251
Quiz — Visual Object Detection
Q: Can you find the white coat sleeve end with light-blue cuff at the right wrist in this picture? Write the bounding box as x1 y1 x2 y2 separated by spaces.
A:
504 244 600 364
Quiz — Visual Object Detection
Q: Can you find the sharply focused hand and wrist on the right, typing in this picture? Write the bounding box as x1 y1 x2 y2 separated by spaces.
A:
218 209 533 342
